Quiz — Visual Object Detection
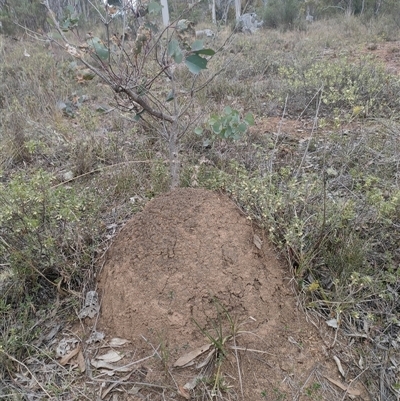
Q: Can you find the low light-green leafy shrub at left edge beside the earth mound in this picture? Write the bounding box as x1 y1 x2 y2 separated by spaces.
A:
0 170 96 304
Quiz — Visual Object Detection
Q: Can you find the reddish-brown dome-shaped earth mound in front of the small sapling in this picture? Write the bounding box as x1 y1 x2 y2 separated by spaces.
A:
97 189 364 400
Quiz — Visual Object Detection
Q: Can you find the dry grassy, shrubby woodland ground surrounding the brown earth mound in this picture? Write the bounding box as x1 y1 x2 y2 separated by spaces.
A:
0 9 400 401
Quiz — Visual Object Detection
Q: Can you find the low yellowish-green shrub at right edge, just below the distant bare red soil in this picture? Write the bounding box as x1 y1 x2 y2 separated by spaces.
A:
279 56 400 118
